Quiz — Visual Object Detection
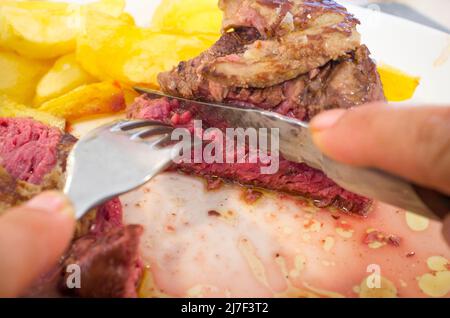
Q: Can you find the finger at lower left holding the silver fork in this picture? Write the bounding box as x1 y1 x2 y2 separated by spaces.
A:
0 192 75 297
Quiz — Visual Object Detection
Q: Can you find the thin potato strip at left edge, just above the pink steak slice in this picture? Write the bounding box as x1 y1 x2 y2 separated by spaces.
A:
0 95 66 130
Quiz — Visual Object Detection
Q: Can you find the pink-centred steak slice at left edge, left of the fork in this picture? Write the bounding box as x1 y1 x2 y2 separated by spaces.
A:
0 118 76 213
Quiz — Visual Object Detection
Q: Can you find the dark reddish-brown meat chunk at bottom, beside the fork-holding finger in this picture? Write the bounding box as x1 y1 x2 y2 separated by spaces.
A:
60 225 143 298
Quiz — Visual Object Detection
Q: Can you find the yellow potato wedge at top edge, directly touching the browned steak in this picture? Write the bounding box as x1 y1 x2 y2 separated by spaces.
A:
151 0 223 36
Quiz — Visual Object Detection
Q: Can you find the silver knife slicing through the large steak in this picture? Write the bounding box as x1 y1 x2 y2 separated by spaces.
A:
135 87 450 220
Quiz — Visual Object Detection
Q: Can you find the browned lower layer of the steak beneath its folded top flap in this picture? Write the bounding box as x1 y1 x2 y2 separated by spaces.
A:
159 43 385 120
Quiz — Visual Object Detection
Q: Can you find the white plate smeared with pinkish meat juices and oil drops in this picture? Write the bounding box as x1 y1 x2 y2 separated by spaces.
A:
67 0 450 297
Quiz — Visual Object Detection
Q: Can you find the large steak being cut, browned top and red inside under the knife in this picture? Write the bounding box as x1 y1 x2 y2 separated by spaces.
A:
150 0 385 215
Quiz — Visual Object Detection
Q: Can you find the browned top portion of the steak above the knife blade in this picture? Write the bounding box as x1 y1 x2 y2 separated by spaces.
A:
158 0 385 115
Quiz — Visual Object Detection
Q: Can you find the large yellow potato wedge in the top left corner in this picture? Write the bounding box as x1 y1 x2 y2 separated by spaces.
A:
0 0 124 59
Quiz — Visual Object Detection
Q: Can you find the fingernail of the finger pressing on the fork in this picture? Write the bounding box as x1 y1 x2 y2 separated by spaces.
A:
25 191 74 216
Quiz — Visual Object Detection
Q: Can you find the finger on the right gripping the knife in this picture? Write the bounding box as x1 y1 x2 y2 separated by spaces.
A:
311 104 450 194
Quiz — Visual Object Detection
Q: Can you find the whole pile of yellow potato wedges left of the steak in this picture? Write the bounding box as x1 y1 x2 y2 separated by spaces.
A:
0 0 221 129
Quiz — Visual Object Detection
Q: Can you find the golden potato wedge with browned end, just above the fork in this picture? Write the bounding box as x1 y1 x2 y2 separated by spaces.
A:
38 82 125 121
